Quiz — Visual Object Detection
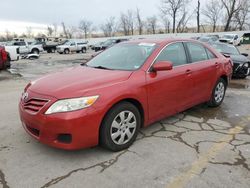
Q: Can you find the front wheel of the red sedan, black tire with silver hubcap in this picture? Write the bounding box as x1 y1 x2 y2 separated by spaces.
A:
100 102 141 151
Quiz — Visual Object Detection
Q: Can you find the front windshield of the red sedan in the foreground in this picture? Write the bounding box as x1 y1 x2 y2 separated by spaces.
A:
86 43 156 70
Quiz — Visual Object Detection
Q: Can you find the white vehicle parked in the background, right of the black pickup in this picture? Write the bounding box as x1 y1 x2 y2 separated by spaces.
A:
56 41 88 54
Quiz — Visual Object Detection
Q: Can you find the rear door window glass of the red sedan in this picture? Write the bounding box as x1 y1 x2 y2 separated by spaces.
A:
187 42 208 63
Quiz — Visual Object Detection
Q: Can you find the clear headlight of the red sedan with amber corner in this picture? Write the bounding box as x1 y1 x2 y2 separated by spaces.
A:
45 96 99 115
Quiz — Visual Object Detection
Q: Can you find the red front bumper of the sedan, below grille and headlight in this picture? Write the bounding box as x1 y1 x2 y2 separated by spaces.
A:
19 91 102 150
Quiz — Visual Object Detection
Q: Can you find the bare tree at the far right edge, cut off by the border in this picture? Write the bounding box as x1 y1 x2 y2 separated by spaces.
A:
234 0 250 30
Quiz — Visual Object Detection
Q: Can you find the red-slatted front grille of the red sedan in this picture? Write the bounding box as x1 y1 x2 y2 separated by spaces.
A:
23 98 49 113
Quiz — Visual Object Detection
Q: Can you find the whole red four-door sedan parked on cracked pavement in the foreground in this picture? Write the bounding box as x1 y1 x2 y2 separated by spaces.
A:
19 39 232 151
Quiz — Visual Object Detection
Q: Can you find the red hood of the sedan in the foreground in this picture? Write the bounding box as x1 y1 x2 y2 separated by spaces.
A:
29 66 132 99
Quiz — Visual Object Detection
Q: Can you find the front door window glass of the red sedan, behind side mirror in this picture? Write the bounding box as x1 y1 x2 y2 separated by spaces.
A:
156 42 187 66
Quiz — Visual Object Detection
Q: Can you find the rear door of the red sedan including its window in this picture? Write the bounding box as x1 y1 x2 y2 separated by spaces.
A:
185 42 219 105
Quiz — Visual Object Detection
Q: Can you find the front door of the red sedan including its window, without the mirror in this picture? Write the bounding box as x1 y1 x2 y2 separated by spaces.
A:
146 42 193 121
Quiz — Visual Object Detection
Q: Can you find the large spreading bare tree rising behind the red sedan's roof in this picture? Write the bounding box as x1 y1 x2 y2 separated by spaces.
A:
160 0 188 33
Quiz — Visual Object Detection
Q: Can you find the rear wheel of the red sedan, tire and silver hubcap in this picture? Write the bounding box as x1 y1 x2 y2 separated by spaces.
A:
208 78 227 107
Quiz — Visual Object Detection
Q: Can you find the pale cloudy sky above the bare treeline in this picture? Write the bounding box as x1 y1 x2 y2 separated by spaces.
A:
0 0 200 34
